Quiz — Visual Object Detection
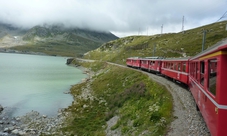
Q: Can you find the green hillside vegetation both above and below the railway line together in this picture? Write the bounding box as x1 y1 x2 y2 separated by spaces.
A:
58 22 227 136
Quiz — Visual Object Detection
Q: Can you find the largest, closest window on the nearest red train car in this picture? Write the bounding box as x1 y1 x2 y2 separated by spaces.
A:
208 59 217 95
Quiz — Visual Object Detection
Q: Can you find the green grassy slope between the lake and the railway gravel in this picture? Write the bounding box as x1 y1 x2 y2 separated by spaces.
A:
63 62 173 136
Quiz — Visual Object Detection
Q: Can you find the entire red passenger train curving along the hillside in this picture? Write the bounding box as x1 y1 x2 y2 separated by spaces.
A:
127 39 227 136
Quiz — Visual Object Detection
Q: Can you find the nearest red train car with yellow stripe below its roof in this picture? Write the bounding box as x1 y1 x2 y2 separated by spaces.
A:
189 39 227 136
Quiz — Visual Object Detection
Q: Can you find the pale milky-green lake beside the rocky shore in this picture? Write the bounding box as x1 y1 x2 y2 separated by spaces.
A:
0 53 86 116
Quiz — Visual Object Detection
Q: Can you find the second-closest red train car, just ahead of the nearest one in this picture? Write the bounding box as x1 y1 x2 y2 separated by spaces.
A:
161 58 189 85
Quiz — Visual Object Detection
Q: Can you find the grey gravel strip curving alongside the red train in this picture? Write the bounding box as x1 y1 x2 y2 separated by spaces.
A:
148 74 210 136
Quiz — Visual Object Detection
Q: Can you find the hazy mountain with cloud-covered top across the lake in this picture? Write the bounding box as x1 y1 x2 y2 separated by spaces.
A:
0 24 118 56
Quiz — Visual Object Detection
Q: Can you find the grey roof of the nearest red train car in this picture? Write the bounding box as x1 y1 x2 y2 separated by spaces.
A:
191 38 227 59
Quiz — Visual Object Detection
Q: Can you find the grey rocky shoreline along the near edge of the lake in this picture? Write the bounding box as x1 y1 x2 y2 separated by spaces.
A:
0 52 88 136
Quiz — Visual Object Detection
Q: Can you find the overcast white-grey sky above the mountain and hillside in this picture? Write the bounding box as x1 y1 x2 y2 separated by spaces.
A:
0 0 227 37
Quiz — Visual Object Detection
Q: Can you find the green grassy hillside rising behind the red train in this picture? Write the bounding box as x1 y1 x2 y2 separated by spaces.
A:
84 21 227 64
